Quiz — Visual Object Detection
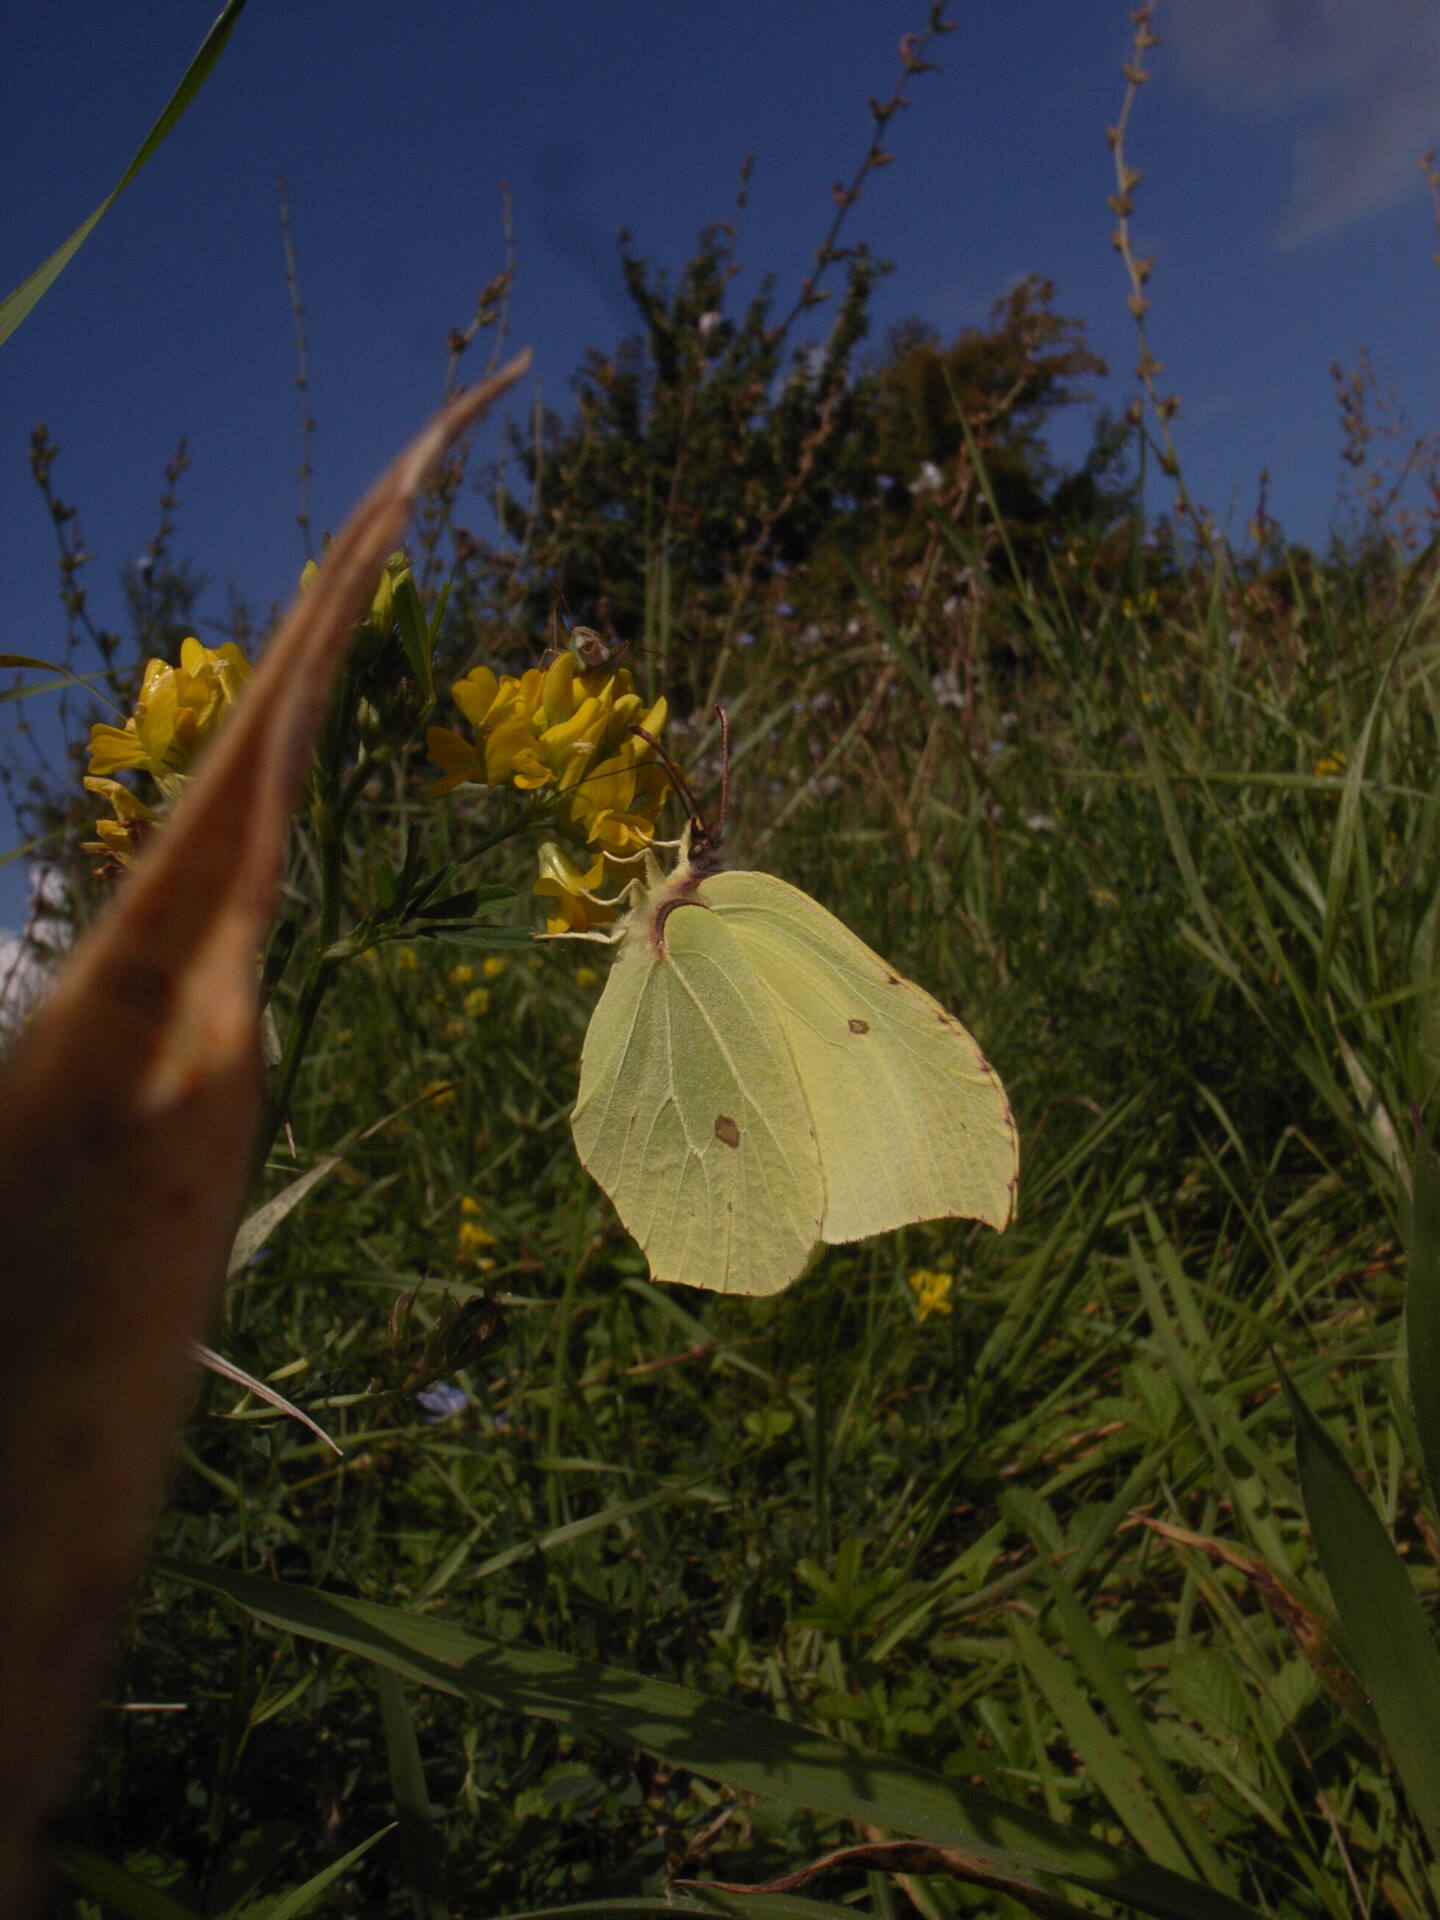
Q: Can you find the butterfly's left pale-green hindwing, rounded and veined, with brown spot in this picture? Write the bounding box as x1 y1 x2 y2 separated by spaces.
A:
570 904 824 1294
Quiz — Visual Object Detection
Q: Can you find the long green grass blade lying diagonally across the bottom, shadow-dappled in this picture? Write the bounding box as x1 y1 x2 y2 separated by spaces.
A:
157 1561 1256 1920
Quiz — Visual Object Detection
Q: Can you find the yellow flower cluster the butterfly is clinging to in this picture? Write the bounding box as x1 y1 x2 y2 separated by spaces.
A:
428 653 668 933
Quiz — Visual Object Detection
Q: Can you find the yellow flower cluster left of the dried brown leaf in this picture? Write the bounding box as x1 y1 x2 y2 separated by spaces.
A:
84 639 250 866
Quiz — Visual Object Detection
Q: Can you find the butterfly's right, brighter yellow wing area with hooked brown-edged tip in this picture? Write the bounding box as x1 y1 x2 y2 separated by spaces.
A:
706 874 1020 1244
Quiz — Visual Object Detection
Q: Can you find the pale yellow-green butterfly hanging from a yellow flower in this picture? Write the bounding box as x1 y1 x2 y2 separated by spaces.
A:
570 729 1020 1294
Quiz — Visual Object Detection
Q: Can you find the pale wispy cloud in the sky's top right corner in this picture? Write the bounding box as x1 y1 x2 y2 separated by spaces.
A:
1156 0 1440 246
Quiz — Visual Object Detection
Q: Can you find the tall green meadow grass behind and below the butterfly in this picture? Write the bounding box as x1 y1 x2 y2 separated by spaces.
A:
33 503 1440 1914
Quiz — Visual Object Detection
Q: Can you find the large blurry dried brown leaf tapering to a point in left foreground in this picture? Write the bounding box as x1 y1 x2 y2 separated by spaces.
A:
0 353 530 1912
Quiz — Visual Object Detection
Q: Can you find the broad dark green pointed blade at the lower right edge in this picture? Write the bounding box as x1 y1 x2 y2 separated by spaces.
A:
1281 1367 1440 1853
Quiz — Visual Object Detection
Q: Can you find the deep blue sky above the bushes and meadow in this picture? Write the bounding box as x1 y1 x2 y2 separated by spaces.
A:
0 0 1440 924
